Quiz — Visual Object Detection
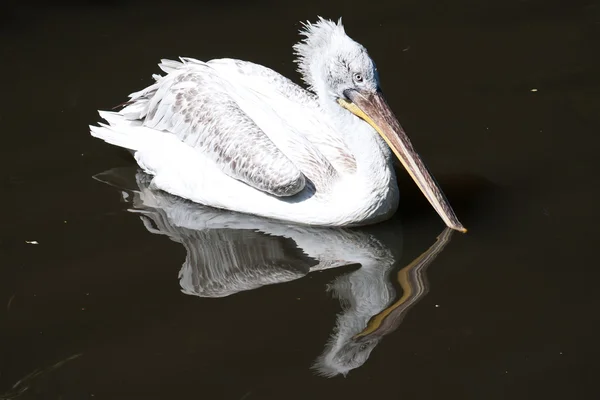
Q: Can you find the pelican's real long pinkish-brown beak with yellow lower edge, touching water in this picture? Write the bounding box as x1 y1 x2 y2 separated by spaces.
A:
338 89 467 233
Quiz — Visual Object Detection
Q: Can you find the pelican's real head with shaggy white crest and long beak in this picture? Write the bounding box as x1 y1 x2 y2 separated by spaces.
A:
294 18 466 232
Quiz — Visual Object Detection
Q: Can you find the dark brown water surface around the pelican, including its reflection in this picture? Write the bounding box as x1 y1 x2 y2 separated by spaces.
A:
0 0 600 400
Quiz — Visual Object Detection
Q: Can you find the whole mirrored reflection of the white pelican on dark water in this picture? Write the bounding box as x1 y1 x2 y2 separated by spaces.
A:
96 170 452 377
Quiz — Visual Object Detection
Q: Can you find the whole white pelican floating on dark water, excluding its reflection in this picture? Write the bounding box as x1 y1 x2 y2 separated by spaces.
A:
90 18 466 232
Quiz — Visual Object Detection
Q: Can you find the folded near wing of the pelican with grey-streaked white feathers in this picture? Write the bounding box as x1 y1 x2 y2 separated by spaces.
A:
121 61 306 196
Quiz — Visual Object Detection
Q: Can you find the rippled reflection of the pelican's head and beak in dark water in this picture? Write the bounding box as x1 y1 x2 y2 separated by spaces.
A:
314 228 452 377
